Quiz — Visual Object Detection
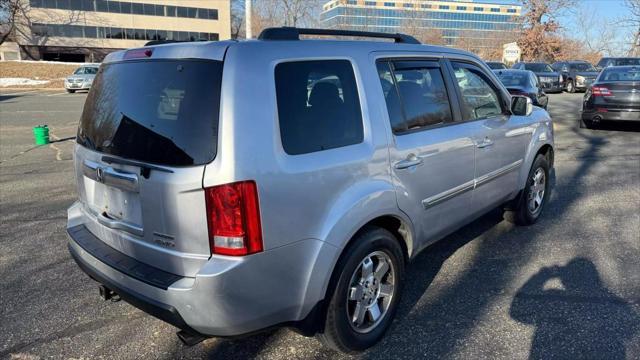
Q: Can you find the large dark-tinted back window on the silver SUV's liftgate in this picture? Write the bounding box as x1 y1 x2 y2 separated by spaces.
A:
77 60 222 166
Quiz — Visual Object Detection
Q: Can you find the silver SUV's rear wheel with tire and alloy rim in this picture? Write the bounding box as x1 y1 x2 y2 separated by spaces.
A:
318 227 404 353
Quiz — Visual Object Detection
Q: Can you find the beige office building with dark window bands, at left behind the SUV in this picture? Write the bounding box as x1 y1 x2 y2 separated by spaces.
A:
15 0 231 62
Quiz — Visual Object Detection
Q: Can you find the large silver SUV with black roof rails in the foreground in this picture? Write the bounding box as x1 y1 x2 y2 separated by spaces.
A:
67 28 553 352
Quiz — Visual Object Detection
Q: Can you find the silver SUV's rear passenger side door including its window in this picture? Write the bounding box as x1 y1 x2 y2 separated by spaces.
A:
377 58 477 247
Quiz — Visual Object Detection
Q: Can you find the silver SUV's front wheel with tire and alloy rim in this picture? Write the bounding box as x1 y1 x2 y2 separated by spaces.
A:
507 155 550 225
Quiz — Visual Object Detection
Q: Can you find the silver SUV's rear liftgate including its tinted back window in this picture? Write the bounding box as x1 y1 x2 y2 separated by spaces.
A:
75 59 223 276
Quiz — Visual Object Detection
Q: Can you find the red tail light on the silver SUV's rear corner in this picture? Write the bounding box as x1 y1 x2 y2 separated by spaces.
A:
205 181 263 256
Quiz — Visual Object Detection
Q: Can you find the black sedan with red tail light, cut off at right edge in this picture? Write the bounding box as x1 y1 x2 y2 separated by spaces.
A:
580 66 640 128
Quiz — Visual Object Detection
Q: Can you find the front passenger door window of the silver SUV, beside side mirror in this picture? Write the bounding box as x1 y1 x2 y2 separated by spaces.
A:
451 62 502 120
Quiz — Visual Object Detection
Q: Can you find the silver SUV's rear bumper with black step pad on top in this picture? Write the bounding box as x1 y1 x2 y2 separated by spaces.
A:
68 205 338 336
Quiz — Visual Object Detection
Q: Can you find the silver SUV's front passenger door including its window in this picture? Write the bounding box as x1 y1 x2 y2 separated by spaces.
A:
450 60 530 211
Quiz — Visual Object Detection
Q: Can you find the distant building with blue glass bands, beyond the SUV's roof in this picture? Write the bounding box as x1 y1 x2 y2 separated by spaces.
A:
321 0 522 46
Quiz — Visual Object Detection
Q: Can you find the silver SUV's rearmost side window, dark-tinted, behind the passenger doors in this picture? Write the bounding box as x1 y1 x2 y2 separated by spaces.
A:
275 60 364 155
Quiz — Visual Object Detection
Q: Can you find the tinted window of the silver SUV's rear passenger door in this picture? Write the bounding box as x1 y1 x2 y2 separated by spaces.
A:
377 61 452 134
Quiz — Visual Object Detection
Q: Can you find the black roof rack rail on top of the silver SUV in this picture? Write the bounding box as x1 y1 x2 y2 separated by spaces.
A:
258 26 420 44
